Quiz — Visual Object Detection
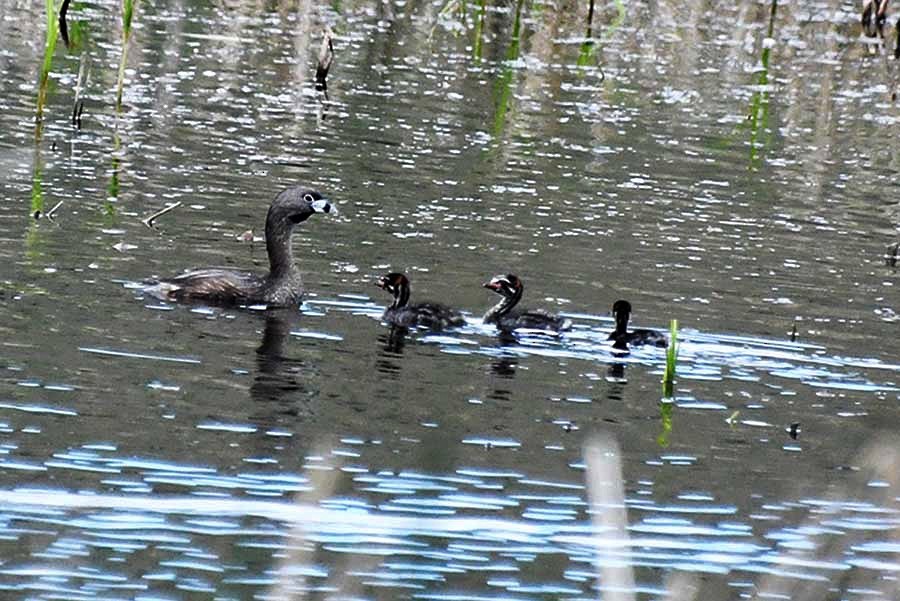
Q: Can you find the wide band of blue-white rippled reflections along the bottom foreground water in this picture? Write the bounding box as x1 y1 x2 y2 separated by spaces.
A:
0 436 898 599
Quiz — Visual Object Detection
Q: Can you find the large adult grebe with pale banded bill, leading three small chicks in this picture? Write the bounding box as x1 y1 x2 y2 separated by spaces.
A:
144 186 336 307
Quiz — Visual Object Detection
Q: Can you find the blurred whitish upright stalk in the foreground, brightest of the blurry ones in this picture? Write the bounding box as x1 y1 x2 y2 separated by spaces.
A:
584 434 634 601
